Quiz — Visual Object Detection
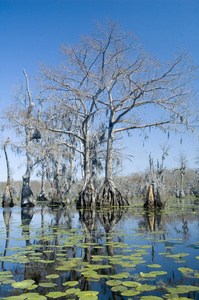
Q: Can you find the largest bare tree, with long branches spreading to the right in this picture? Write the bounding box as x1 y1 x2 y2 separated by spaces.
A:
95 23 196 205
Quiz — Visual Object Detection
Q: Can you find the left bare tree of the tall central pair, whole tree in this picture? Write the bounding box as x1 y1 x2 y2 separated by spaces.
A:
39 34 107 206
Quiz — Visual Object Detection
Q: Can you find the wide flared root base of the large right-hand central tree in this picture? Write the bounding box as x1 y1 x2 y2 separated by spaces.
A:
96 179 129 207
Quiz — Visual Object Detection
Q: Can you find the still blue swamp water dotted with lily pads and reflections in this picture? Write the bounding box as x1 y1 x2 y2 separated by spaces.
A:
0 198 199 300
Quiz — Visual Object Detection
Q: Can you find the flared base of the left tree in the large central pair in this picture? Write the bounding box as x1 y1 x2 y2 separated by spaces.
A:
77 182 95 208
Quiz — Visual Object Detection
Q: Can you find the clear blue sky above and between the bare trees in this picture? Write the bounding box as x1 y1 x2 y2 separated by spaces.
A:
0 0 199 181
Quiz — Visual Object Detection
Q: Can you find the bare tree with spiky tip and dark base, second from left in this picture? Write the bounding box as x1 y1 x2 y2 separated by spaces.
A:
5 70 41 207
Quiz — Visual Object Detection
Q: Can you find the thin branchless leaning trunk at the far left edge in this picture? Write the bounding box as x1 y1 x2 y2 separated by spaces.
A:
2 138 14 207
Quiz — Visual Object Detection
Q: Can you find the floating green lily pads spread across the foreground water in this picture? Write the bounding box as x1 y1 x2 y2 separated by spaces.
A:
0 199 199 300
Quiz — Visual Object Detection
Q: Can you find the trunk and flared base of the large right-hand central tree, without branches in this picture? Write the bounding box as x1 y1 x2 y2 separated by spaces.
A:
96 122 129 206
